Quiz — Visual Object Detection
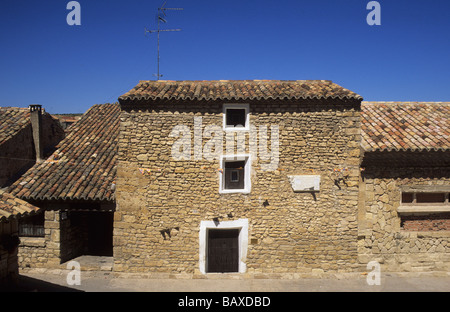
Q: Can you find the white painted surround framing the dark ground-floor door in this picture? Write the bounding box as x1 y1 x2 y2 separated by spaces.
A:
199 219 248 274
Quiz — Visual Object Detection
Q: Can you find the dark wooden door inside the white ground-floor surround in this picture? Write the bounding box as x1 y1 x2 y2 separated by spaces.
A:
207 229 239 273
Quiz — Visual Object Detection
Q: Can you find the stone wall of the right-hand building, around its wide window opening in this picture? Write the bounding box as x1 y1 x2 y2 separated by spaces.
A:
358 166 450 272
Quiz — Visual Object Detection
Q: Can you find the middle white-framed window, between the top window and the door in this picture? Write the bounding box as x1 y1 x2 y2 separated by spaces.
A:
219 154 251 194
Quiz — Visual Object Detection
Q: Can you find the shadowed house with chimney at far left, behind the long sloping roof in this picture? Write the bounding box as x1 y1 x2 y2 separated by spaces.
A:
0 105 64 188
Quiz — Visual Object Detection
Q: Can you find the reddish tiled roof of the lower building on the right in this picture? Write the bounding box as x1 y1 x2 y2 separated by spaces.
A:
361 102 450 151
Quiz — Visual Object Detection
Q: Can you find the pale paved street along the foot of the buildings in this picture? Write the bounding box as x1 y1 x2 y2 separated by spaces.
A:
6 271 450 292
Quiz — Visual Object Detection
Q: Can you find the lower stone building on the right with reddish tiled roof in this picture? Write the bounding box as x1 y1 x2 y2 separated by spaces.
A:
358 102 450 272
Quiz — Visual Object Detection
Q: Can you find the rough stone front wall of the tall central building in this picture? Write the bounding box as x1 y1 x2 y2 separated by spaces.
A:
114 101 360 274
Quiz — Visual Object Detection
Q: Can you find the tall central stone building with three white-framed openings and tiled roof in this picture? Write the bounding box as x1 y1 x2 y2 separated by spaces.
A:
114 81 362 274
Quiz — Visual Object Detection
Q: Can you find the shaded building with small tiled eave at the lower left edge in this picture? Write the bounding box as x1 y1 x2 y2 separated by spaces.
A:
0 190 39 290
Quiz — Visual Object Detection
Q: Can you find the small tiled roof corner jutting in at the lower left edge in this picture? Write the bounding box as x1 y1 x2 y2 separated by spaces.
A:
0 190 39 222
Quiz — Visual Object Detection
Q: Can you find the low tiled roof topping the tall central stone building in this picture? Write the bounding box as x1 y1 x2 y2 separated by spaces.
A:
119 80 362 104
